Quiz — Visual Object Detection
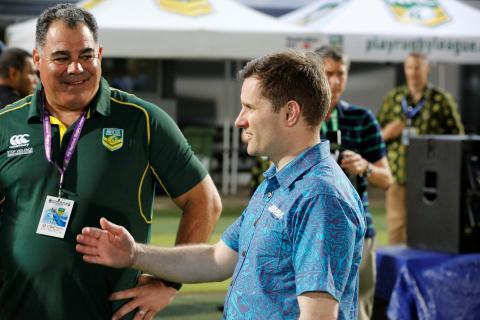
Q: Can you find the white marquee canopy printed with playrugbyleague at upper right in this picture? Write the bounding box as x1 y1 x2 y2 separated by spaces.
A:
280 0 480 64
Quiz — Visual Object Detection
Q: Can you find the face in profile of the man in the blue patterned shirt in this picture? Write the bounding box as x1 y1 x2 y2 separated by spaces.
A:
235 77 283 161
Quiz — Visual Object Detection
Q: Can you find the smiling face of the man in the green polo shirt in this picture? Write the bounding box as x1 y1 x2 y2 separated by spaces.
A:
33 20 102 111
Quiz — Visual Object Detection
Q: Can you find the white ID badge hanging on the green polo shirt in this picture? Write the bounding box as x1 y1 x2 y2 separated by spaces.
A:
37 196 74 238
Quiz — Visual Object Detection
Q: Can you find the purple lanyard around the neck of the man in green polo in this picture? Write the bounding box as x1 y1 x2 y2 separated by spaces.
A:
43 107 87 198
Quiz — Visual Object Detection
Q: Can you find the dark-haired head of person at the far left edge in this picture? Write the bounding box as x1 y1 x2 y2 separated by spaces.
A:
0 48 38 109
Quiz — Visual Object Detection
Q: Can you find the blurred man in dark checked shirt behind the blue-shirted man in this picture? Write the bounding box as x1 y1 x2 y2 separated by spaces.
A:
315 46 392 320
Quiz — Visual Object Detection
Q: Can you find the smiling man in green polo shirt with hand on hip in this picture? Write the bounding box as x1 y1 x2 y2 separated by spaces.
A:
0 4 221 320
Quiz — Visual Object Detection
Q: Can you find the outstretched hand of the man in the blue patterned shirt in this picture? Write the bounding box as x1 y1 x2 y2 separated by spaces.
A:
75 218 136 268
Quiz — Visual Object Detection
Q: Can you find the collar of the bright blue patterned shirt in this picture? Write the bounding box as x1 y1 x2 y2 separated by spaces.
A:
264 141 330 188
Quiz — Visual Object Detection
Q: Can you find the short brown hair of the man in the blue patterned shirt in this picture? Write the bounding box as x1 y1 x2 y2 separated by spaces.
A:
239 50 331 126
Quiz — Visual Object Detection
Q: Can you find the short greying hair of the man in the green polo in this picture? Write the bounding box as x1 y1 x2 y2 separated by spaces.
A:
35 3 98 49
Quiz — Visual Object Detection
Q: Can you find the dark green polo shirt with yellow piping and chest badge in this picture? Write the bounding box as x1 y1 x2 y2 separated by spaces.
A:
0 79 207 320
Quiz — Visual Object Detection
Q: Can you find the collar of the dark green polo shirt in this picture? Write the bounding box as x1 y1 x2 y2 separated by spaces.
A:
28 77 110 121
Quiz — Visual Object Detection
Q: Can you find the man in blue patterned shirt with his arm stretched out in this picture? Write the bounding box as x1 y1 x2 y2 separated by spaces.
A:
77 51 366 320
